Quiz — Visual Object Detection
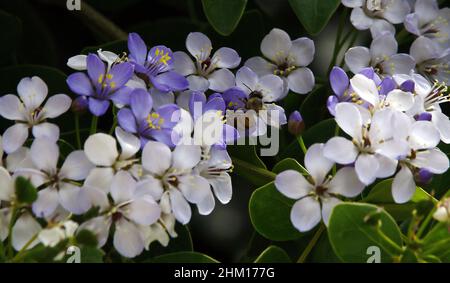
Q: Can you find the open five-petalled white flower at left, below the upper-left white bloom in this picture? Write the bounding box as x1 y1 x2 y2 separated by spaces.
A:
16 139 93 217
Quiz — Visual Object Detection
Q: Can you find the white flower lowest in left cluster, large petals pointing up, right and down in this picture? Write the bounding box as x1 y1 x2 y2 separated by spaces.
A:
78 171 161 258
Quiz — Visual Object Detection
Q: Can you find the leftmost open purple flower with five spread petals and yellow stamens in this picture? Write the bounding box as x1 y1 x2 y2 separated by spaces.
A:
67 54 133 116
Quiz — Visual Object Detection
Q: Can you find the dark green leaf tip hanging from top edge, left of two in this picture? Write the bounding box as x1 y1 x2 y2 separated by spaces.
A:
202 0 247 35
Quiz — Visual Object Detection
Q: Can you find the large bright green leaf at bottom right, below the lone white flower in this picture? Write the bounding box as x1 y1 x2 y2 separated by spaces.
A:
328 203 402 263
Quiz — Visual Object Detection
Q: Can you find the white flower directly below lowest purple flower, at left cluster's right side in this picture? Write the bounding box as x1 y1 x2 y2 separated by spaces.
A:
140 141 215 224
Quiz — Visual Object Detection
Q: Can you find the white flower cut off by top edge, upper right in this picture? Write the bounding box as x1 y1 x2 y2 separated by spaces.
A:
342 0 410 38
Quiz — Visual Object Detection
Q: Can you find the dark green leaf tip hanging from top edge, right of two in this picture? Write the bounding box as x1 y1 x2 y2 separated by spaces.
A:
289 0 341 35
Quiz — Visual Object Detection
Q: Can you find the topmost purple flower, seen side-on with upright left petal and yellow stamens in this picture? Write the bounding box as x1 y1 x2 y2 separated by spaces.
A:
128 33 189 92
